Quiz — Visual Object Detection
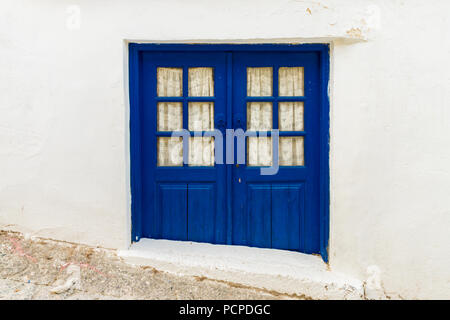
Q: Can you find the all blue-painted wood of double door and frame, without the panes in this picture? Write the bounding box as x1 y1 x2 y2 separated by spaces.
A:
129 43 329 261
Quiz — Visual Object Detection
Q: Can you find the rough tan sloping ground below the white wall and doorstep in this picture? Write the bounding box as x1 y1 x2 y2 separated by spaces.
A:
0 231 297 300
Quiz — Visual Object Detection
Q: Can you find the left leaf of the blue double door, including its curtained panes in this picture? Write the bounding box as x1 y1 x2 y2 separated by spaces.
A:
139 52 227 243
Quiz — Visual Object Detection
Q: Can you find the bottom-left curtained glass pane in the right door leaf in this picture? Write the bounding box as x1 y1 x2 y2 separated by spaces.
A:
247 137 272 166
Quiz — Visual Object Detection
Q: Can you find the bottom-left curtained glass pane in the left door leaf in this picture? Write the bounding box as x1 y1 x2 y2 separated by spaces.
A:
157 137 183 167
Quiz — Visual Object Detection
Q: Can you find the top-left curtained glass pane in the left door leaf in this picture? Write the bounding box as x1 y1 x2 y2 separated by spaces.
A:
157 68 183 97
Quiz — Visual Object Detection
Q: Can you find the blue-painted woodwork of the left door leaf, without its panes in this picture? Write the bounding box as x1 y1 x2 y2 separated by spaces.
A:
138 51 227 243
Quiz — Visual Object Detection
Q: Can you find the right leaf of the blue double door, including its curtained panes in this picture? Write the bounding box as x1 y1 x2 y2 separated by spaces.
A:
232 52 320 253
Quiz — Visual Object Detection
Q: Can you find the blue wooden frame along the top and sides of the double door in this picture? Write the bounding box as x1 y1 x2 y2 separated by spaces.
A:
128 43 330 262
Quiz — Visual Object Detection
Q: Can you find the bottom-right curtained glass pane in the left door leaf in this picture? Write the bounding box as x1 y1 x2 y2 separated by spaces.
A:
189 137 214 166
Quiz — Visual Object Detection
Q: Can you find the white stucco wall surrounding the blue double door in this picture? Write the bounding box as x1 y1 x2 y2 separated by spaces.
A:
0 0 450 298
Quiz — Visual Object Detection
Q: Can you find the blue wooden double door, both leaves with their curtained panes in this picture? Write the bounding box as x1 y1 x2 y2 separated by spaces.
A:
134 45 326 257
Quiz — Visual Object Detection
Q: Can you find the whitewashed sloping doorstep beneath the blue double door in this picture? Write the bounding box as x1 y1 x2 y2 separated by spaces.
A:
118 239 364 299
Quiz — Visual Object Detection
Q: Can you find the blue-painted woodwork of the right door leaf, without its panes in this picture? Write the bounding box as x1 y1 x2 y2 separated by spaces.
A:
232 52 320 253
